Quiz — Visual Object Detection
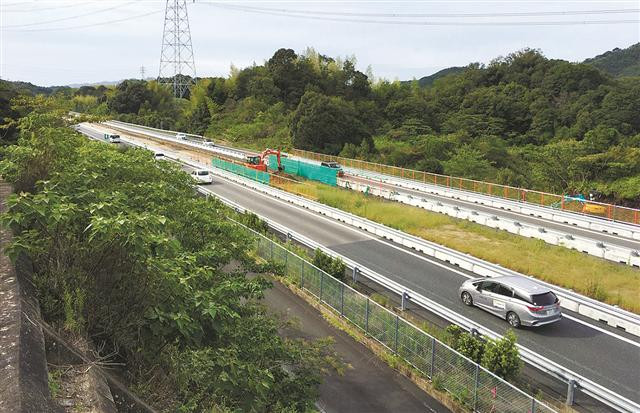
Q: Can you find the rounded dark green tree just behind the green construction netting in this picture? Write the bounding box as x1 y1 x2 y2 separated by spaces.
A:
291 91 371 155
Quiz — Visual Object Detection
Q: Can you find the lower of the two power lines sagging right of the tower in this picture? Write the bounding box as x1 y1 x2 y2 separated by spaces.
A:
205 3 640 26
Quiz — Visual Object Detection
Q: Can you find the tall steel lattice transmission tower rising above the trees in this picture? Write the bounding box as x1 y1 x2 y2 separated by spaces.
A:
158 0 196 98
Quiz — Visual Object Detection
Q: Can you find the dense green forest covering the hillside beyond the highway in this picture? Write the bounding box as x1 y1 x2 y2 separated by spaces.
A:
3 45 640 206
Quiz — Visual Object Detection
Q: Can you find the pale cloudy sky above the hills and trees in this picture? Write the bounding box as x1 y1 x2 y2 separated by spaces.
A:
0 0 640 86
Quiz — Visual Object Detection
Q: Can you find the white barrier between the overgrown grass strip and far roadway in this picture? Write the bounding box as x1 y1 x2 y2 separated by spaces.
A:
338 175 640 267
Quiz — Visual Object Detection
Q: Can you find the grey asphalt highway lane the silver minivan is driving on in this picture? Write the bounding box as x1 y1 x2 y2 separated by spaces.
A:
80 123 640 408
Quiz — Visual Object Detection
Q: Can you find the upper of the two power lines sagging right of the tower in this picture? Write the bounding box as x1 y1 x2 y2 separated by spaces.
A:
204 1 640 18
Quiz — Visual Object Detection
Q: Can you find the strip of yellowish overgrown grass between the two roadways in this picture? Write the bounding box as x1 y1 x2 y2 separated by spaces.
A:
278 181 640 313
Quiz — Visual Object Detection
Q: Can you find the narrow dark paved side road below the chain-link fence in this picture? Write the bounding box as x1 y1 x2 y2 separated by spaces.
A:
265 281 450 413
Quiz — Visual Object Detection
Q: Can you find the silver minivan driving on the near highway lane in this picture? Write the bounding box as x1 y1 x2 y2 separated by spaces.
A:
458 276 562 328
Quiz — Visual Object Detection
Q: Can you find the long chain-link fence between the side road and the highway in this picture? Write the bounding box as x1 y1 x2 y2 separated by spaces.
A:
239 227 555 413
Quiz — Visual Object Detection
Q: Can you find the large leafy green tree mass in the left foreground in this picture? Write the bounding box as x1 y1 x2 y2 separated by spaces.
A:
1 108 337 412
